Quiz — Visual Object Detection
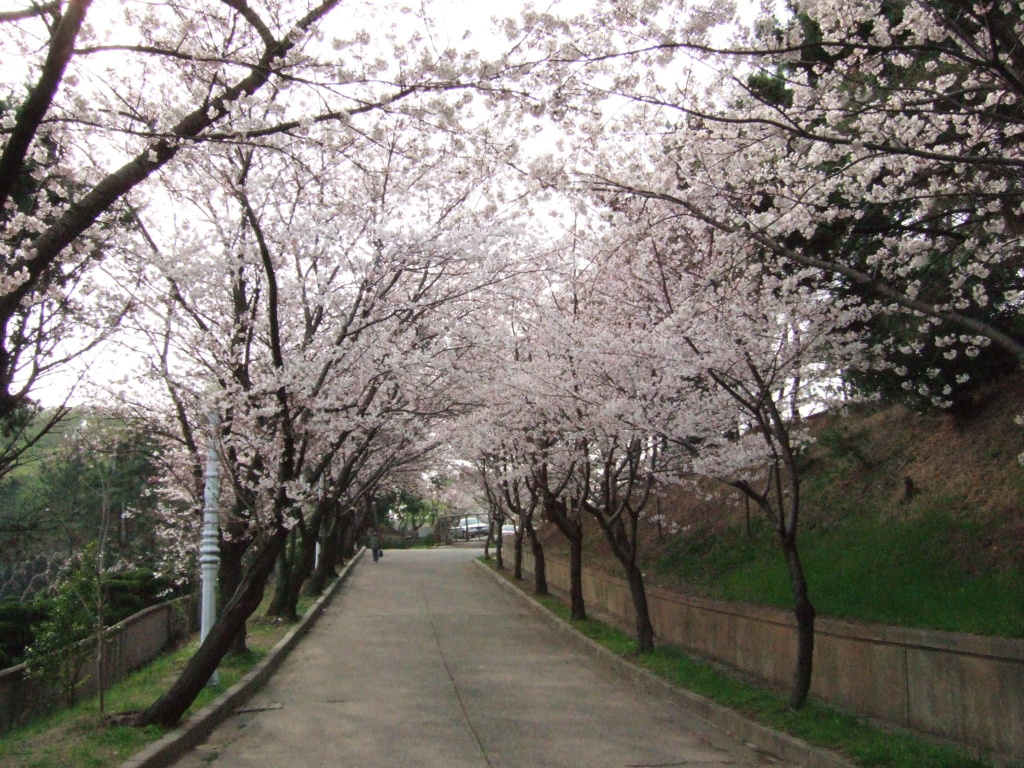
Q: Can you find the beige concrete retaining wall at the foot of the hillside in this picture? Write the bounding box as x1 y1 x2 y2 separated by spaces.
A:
523 552 1024 760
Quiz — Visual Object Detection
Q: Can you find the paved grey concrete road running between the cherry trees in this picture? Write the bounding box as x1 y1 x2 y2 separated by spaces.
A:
177 549 774 768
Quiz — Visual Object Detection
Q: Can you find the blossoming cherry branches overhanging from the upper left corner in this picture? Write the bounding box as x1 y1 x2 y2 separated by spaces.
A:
0 0 557 487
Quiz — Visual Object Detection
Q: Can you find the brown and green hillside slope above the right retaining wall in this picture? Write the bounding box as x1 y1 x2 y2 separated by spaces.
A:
544 376 1024 637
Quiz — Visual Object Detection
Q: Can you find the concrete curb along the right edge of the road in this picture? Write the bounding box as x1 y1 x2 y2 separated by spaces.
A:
474 560 858 768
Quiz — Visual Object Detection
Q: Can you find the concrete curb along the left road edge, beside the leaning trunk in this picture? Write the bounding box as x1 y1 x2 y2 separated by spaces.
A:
119 548 366 768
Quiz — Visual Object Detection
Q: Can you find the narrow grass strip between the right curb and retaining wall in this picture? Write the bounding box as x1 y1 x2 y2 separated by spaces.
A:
481 558 1007 768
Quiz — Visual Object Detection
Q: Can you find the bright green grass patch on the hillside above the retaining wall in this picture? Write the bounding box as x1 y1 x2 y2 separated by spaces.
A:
650 512 1024 638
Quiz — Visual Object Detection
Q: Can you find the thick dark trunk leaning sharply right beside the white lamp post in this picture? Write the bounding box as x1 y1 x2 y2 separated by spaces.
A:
132 527 288 727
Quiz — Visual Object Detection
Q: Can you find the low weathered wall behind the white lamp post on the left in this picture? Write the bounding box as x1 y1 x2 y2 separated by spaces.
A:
0 597 197 733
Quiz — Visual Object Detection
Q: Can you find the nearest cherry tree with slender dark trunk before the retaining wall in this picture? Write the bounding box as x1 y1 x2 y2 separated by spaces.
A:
569 185 871 708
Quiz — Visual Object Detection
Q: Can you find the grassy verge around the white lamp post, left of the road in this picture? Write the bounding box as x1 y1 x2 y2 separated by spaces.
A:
0 598 313 768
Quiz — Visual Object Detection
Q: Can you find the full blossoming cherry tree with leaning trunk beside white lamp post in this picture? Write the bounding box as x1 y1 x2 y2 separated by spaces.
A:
107 78 544 722
